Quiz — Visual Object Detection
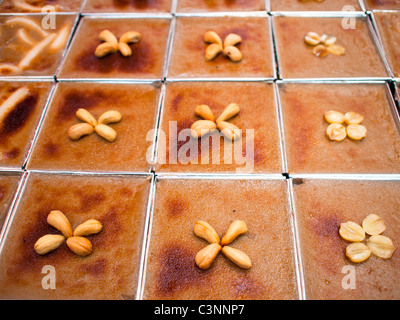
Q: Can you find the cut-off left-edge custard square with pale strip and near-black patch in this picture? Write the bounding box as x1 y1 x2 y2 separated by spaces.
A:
0 81 53 168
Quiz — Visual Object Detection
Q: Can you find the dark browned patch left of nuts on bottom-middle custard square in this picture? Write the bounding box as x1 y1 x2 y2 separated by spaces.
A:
156 243 208 297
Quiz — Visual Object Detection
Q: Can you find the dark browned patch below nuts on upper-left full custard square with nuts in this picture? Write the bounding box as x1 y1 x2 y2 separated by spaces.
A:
75 40 155 74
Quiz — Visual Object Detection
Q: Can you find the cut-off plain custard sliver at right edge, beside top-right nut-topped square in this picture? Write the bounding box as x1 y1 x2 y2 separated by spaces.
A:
373 11 400 77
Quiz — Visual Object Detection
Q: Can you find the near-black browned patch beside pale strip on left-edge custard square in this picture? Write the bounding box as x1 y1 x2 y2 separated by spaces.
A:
0 92 39 142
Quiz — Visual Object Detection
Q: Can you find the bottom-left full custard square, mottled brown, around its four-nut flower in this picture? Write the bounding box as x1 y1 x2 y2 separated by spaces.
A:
0 173 150 300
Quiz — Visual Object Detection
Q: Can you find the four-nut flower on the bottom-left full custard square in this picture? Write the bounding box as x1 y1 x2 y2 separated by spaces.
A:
34 210 103 257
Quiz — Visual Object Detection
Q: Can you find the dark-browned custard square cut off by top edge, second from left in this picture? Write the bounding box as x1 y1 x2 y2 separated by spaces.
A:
82 0 172 13
